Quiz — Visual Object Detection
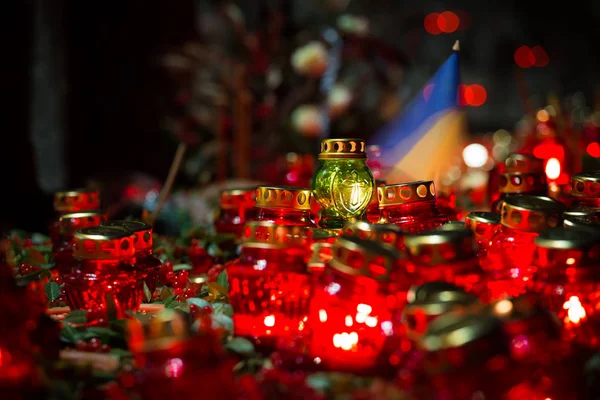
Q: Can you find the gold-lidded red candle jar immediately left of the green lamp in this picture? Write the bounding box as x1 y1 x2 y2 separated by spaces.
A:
256 186 315 227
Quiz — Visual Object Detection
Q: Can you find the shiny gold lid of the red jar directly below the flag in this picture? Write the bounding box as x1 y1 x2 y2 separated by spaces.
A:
404 228 475 266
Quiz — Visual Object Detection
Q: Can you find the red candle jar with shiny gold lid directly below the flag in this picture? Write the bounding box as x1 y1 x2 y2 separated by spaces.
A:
403 225 483 295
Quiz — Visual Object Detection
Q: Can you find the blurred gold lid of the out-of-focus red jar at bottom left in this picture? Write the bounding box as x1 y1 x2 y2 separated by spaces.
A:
127 309 191 353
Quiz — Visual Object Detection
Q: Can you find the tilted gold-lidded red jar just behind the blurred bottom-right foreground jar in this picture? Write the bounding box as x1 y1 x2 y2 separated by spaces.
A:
402 281 481 341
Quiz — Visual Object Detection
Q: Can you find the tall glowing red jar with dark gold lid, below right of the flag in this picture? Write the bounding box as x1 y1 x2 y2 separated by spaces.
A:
486 196 565 300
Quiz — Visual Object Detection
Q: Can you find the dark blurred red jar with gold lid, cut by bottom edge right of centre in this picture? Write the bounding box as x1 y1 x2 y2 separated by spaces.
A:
419 313 518 400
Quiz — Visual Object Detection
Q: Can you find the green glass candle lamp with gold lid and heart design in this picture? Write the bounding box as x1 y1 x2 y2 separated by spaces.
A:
313 139 375 229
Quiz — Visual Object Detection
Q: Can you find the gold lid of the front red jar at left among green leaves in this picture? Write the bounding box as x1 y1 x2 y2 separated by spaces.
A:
73 226 135 260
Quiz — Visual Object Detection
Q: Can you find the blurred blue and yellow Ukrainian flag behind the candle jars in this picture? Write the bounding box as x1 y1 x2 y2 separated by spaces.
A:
369 42 465 184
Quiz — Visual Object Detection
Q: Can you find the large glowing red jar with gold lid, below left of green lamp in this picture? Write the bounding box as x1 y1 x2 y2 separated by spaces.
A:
226 221 312 348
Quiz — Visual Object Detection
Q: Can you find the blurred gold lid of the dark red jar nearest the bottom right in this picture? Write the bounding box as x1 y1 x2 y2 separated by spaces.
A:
419 312 503 352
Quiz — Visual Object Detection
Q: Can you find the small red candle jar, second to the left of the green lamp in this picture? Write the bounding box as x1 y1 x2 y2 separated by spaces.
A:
214 188 256 237
